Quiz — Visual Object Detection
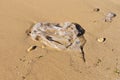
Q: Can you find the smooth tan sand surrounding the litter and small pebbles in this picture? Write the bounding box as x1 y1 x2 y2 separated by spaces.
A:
0 0 120 80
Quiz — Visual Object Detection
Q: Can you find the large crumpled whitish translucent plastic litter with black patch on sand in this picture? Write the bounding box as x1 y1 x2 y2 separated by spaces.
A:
26 22 86 61
